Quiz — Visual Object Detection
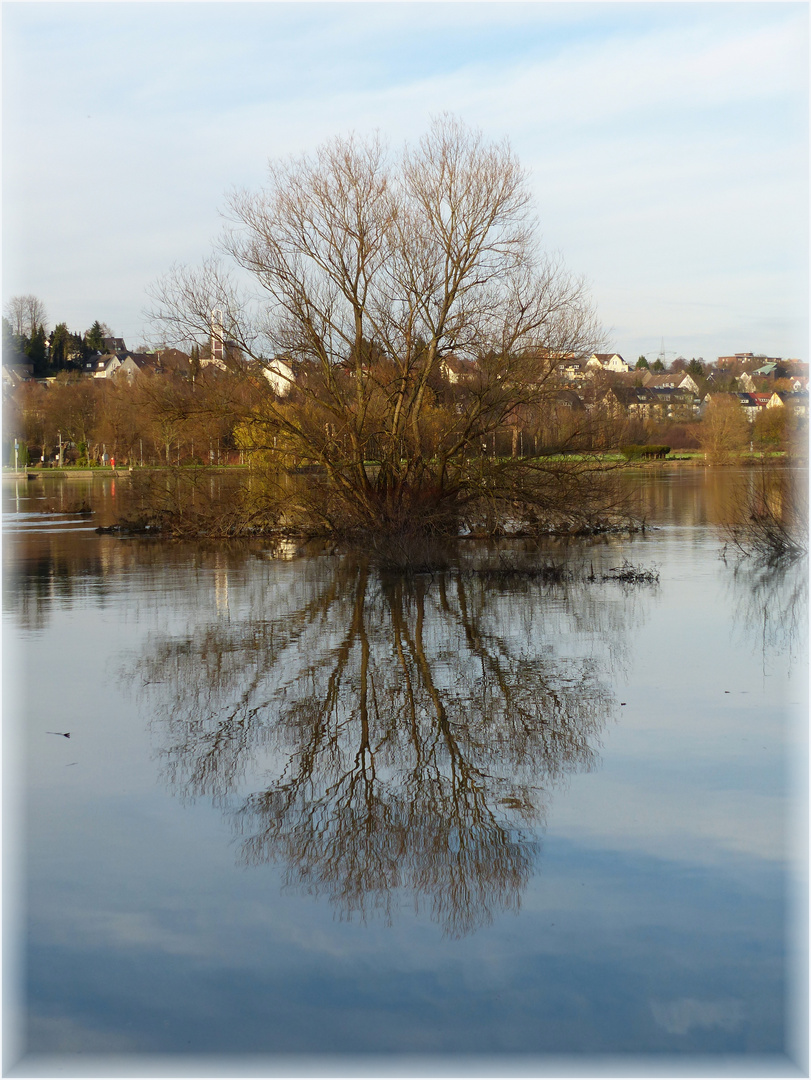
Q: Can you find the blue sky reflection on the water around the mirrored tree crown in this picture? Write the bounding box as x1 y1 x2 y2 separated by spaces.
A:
5 479 807 1075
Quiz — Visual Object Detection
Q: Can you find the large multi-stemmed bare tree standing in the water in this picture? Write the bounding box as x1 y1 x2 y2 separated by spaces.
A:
151 117 606 540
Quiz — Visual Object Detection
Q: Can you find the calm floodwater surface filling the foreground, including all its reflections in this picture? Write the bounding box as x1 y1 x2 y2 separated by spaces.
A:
3 469 808 1077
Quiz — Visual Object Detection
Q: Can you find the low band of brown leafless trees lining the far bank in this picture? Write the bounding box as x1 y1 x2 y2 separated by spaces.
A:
3 356 807 467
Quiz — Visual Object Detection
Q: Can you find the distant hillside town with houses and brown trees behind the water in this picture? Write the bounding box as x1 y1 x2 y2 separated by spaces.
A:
2 297 808 468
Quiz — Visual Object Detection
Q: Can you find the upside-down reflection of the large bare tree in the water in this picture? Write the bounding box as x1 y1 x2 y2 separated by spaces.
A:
131 559 639 935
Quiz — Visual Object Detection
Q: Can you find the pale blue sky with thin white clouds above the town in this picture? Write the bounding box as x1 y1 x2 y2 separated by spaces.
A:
2 2 809 364
